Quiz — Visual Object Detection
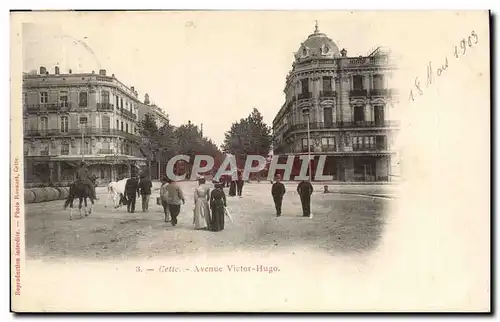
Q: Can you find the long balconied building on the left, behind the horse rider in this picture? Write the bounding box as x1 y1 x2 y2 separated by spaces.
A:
23 67 145 185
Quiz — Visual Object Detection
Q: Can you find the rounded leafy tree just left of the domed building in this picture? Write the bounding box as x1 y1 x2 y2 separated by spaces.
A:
221 108 272 165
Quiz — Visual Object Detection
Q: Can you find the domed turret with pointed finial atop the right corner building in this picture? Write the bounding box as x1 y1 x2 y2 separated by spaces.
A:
295 22 340 61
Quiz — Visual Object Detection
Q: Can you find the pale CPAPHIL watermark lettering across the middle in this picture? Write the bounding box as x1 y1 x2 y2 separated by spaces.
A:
166 154 333 181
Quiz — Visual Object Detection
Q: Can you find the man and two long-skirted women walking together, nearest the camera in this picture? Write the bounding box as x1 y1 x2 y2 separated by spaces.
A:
160 178 227 232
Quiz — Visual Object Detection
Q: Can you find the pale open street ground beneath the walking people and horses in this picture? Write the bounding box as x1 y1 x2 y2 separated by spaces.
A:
25 182 392 261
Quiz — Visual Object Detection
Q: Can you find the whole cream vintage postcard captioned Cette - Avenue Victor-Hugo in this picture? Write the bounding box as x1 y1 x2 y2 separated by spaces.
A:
10 11 491 312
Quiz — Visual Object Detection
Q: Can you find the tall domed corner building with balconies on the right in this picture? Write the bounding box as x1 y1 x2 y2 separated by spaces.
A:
273 26 398 182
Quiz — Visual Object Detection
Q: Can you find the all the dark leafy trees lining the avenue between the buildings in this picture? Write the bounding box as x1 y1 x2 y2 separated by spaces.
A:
137 108 272 179
